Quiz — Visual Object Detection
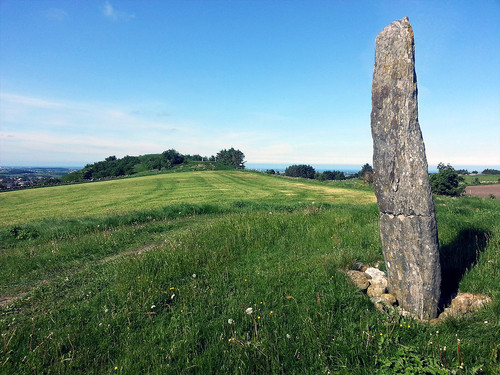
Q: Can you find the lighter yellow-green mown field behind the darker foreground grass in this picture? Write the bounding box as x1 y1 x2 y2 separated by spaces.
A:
0 170 375 226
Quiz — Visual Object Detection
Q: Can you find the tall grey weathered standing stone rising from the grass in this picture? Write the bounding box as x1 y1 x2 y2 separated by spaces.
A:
371 17 441 319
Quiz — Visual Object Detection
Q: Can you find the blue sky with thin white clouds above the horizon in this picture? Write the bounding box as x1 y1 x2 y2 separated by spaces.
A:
0 0 500 167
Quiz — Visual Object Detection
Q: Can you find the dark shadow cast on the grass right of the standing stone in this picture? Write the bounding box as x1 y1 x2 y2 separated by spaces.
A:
438 228 490 311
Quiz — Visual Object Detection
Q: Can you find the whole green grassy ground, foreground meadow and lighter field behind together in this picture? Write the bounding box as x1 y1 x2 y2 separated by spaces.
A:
0 171 500 374
